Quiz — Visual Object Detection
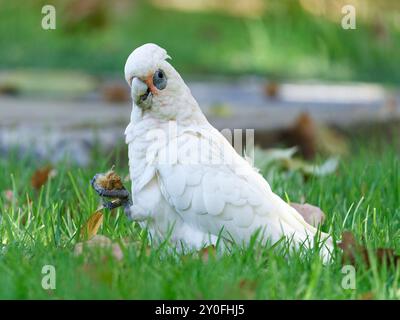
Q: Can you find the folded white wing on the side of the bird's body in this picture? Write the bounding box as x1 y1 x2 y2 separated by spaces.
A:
156 128 330 248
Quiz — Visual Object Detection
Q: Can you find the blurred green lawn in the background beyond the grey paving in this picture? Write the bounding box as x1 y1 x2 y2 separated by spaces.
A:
0 0 400 83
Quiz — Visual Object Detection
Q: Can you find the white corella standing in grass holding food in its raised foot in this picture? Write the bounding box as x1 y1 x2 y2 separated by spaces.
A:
92 43 332 259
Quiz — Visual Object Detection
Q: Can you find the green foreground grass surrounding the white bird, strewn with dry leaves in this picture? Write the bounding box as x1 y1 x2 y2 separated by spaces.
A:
0 138 400 299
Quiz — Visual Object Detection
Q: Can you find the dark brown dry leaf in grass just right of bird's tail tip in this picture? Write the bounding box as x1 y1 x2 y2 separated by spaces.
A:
339 231 400 267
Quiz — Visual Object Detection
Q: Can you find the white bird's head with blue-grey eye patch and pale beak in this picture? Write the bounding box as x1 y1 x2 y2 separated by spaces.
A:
125 43 194 120
